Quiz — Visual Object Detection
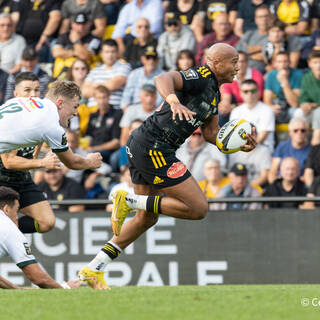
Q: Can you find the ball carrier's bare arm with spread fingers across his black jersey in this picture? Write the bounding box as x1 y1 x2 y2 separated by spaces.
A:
154 71 196 120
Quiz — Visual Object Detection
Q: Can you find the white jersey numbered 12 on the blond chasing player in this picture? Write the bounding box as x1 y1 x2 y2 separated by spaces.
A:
0 98 68 153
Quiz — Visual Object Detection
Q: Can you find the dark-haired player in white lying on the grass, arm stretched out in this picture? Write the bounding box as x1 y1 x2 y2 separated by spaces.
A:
0 187 80 289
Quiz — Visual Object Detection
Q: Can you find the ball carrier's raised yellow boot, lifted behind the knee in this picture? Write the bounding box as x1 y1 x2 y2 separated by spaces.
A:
111 190 133 236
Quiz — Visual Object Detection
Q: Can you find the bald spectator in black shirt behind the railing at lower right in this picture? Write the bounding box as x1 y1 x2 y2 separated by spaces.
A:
263 157 307 208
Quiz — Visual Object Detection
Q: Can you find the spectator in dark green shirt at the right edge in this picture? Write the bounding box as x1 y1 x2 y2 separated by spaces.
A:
295 50 320 145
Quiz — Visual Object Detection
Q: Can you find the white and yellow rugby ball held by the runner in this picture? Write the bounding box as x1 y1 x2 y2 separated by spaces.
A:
216 119 252 153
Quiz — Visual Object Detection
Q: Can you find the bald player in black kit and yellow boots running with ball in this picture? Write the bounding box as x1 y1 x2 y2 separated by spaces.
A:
79 43 257 289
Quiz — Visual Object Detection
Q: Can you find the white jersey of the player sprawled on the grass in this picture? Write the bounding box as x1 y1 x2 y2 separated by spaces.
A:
0 210 37 268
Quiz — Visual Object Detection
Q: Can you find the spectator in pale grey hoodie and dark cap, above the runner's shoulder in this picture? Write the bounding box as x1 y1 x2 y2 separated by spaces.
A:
157 13 196 71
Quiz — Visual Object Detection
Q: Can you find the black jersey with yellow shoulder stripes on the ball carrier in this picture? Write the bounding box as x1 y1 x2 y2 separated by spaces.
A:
132 65 220 150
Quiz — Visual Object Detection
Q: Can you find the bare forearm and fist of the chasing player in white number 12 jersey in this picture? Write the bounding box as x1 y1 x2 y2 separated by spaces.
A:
57 149 102 170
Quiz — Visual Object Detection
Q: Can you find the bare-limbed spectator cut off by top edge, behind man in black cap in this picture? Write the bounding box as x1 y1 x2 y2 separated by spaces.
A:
59 0 106 38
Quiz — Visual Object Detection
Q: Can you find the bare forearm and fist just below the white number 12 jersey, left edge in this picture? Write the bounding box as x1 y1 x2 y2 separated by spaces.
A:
1 150 60 170
